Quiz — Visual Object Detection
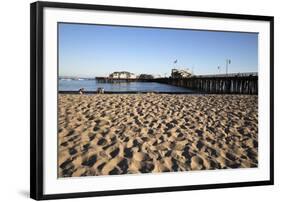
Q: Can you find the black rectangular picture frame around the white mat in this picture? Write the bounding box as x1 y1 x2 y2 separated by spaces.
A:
30 2 274 200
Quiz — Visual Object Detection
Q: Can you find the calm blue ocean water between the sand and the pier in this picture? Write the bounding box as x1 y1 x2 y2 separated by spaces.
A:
59 79 192 93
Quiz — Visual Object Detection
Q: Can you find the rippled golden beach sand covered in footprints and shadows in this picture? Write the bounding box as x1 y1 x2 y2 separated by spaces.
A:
58 94 258 177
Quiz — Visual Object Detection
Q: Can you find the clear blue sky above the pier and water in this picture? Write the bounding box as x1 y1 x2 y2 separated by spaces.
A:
59 23 258 77
